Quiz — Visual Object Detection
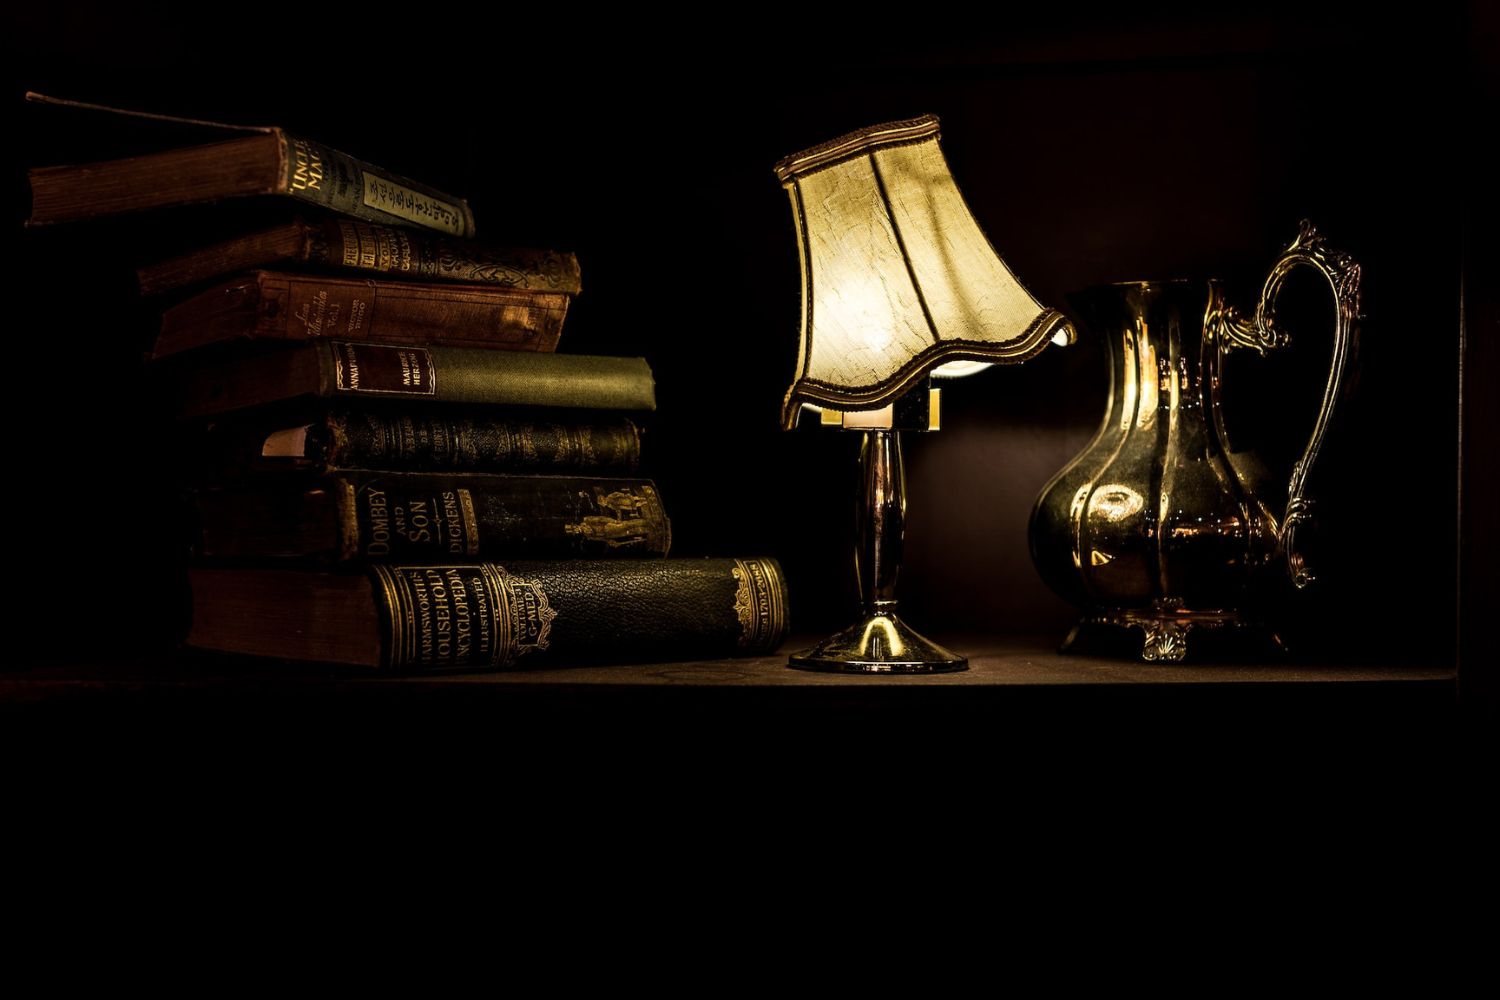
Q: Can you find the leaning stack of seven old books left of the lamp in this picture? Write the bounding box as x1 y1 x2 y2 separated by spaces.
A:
30 93 786 670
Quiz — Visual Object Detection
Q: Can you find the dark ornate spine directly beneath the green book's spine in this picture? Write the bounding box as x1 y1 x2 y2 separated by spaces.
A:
322 411 641 472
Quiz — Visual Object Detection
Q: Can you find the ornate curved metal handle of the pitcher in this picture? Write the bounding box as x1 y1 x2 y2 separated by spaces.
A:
1224 219 1361 588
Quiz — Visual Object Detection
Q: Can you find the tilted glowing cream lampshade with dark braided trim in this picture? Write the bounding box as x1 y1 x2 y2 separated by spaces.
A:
776 115 1073 429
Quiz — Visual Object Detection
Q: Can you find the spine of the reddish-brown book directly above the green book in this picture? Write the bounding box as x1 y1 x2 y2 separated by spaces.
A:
249 271 569 351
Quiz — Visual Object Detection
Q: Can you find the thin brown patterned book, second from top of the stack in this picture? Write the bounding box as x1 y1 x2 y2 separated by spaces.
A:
135 216 582 295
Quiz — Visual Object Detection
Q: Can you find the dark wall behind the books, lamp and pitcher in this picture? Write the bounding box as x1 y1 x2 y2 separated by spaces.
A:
6 3 1496 680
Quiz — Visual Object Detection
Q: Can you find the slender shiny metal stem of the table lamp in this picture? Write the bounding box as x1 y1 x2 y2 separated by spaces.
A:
854 430 906 615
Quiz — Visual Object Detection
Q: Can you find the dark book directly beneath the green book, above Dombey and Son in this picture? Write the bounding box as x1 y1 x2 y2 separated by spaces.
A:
201 405 641 478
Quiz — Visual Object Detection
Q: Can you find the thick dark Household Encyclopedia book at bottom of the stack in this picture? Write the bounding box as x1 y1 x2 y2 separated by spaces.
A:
188 559 788 672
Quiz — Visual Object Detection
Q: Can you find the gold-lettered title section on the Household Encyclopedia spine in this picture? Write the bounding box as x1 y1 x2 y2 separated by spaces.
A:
371 562 557 670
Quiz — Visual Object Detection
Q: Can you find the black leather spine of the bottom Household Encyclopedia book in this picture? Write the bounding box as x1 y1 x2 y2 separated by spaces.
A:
371 559 788 672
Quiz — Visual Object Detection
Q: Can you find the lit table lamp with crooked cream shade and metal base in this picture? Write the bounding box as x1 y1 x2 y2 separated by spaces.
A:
776 115 1074 673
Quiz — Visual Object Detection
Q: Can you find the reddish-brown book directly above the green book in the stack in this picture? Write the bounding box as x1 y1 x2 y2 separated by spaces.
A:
155 271 570 357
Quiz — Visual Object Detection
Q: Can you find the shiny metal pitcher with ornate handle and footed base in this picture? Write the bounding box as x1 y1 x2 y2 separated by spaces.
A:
1031 222 1359 661
